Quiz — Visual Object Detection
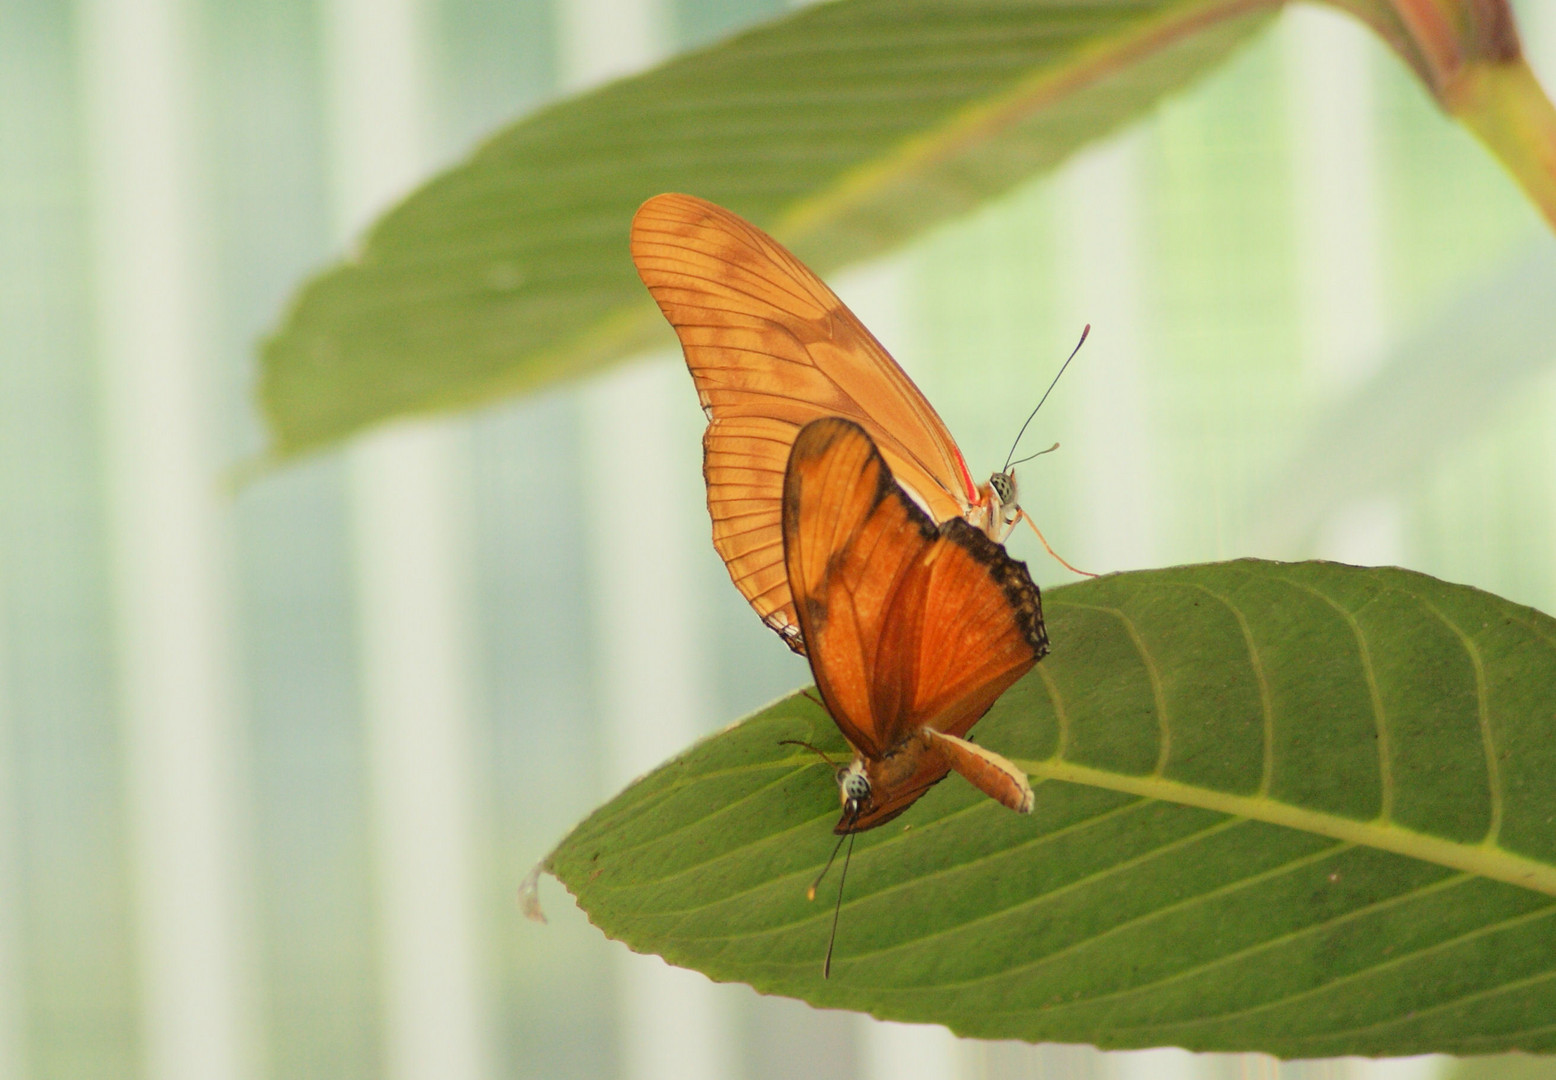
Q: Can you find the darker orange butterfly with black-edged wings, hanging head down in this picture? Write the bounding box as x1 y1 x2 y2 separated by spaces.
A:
783 419 1047 833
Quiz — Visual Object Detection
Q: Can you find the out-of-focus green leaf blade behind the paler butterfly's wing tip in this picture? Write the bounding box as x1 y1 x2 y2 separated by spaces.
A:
260 0 1277 454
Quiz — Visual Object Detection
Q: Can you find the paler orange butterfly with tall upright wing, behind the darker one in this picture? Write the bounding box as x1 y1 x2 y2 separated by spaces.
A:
632 195 1021 652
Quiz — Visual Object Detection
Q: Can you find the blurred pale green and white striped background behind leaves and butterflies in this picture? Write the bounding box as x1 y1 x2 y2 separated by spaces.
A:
9 0 1556 1080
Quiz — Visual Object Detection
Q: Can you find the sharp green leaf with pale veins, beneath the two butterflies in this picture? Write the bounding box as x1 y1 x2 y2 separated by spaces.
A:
548 560 1556 1057
